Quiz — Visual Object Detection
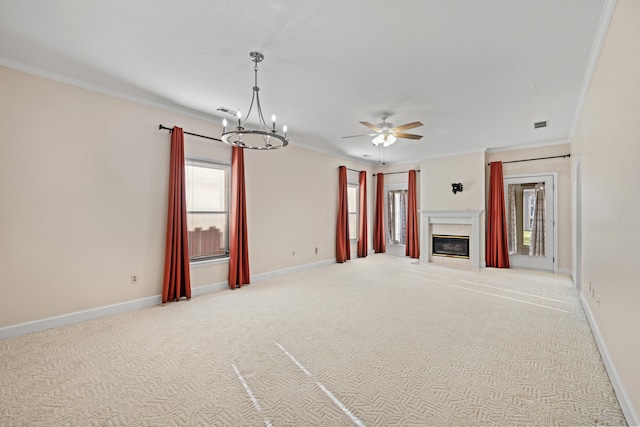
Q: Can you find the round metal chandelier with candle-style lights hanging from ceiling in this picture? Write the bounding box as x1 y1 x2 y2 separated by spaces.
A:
218 52 289 150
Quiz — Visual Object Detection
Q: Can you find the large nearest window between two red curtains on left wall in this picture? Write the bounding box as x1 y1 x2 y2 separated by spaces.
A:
185 159 230 261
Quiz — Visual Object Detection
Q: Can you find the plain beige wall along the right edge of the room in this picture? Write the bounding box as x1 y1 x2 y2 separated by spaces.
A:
571 0 640 423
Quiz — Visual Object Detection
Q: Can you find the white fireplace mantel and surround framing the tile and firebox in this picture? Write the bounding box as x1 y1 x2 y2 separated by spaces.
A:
420 209 484 268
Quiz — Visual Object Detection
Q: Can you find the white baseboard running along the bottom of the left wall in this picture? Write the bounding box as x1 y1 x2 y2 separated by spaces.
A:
0 258 336 340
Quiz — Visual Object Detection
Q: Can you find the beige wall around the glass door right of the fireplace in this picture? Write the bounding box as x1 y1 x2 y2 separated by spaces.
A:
486 144 573 274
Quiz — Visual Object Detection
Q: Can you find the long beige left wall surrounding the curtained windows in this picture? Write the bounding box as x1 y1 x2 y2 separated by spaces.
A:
0 67 371 327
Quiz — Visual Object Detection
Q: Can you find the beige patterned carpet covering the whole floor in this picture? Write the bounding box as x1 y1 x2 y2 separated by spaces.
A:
0 255 625 426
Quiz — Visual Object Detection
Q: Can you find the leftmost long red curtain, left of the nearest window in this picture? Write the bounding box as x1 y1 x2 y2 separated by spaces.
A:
162 126 191 304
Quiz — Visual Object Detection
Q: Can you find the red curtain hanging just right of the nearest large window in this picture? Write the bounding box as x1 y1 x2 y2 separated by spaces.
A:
229 147 251 289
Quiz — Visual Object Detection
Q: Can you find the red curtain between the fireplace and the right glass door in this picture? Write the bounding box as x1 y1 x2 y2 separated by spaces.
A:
486 162 509 268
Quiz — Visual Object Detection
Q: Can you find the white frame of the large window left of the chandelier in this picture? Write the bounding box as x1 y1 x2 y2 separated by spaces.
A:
185 157 231 265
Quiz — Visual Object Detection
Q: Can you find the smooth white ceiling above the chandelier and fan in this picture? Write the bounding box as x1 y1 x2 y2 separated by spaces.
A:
0 0 607 163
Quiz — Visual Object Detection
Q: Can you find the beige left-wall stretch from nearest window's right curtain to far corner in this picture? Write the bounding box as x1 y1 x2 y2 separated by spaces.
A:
245 145 371 275
